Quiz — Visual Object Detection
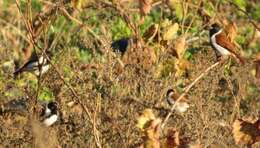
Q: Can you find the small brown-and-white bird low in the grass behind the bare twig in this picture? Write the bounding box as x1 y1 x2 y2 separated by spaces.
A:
166 89 190 113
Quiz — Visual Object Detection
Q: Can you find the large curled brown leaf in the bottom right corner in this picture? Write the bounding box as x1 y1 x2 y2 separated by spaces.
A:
232 119 260 146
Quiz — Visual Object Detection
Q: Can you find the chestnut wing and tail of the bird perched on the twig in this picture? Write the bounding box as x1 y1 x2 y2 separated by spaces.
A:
216 33 245 64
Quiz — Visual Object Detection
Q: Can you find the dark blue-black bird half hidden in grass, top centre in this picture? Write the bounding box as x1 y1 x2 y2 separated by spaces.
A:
111 38 130 55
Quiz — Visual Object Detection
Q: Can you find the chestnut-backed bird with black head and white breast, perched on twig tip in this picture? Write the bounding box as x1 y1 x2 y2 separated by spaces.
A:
209 23 245 64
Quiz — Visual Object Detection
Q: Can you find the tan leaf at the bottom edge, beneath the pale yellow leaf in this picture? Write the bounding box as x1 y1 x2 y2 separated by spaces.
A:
142 119 162 148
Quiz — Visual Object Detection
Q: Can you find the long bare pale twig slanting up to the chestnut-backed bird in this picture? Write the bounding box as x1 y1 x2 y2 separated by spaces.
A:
161 61 222 129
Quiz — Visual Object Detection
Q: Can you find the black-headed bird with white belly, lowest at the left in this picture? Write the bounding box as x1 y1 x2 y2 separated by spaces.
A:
40 101 59 127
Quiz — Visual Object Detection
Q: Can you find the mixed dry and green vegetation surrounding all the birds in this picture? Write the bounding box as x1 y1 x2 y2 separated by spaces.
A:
0 0 260 147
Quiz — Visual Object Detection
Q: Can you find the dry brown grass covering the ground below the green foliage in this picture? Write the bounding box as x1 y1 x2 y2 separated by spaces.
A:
0 0 260 147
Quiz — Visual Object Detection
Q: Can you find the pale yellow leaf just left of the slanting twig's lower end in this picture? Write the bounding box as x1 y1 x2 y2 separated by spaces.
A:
136 109 155 130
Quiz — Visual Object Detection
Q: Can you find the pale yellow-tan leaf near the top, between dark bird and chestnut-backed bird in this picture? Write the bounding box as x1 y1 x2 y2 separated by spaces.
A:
163 23 179 41
